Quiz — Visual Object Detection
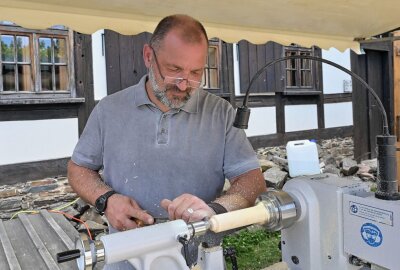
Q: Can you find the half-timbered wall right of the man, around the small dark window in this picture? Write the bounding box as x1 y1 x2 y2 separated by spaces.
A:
235 41 352 147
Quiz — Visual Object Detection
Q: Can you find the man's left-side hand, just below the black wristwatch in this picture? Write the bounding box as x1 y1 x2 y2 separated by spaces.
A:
105 194 154 231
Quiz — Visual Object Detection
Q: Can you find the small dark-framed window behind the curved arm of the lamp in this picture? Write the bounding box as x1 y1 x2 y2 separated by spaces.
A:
284 46 317 92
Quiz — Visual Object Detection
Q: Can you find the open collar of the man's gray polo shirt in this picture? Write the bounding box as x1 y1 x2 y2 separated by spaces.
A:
134 75 201 113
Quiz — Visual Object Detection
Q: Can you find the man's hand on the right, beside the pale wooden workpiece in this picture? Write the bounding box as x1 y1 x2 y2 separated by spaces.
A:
161 194 215 222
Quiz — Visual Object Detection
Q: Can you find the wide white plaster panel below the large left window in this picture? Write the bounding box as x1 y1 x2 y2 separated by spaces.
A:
0 118 78 165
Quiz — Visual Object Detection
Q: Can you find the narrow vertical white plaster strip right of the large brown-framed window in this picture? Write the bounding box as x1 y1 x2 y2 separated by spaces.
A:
92 30 107 100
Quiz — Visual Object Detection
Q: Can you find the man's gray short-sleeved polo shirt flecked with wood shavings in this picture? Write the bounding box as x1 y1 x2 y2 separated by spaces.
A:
72 76 259 217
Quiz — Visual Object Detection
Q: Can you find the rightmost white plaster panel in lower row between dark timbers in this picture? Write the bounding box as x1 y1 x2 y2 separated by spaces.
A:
324 102 353 128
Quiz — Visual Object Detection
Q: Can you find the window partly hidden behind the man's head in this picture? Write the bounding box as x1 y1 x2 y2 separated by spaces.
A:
203 40 221 89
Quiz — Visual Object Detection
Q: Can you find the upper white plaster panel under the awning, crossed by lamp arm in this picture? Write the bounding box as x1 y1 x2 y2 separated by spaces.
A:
322 48 351 94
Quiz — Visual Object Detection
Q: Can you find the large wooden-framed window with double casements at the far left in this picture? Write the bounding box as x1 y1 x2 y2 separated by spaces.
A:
0 24 75 100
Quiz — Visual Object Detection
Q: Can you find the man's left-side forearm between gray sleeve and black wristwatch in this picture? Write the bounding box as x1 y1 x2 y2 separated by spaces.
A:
68 160 111 205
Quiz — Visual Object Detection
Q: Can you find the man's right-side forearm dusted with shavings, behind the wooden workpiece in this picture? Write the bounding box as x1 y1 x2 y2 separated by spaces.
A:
214 169 267 211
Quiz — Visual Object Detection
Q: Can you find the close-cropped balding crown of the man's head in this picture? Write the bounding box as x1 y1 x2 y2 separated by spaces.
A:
150 14 208 50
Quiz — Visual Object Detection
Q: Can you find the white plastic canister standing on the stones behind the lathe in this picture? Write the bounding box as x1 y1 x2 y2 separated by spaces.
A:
286 140 321 177
